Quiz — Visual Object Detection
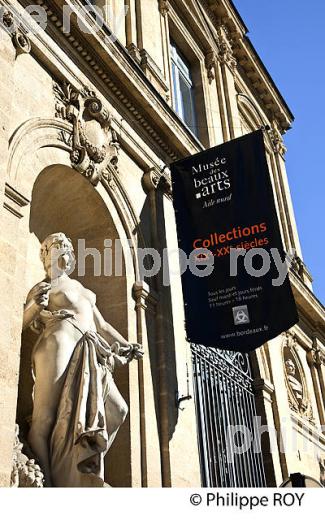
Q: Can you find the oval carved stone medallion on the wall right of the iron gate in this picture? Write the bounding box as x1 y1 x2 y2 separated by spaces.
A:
282 332 314 422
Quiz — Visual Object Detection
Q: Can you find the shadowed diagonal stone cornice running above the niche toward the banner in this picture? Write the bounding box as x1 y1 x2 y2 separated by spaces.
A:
20 0 202 162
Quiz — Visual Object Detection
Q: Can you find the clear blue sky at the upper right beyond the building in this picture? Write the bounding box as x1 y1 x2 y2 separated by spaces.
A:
233 0 325 303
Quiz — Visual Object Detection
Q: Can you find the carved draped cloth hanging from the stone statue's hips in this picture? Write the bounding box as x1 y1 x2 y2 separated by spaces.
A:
50 319 113 487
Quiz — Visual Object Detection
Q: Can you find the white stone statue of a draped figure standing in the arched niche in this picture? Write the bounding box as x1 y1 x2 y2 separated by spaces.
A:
24 233 143 487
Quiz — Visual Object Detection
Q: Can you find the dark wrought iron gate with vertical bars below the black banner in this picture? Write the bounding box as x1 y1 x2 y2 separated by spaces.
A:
191 344 266 487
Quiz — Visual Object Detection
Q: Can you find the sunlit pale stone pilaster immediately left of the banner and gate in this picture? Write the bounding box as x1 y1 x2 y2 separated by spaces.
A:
158 177 202 487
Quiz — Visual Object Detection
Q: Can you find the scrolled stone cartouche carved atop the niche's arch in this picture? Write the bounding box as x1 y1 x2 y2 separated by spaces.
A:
53 83 119 185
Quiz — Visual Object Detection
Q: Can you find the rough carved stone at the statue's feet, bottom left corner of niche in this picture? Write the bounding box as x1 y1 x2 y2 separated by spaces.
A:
10 424 44 488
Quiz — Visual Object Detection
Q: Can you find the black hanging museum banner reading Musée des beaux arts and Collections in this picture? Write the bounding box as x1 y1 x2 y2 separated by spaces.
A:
171 130 298 352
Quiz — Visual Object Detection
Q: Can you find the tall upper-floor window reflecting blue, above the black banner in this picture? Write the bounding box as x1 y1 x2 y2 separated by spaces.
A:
171 42 198 136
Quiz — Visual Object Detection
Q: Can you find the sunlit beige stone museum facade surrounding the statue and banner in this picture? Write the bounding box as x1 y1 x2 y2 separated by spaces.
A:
0 0 325 487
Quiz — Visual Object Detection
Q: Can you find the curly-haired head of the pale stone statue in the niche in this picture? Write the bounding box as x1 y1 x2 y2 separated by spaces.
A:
40 233 75 278
